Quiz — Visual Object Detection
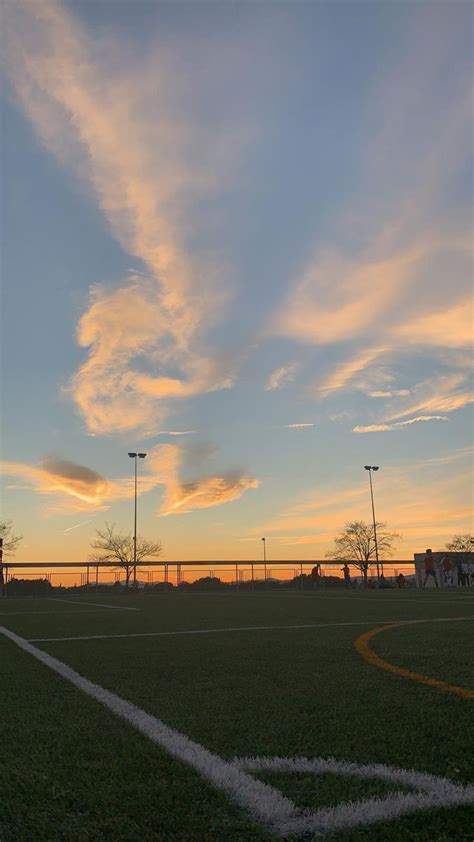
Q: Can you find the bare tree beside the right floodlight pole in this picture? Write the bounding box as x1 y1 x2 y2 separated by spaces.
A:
326 520 401 585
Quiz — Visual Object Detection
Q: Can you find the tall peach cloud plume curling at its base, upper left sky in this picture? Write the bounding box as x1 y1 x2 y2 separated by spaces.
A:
5 0 252 433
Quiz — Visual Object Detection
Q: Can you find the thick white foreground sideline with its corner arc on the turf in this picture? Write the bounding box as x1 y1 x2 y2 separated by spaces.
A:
0 626 474 837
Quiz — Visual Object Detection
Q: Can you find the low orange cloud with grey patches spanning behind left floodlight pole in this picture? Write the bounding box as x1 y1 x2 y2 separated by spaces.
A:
0 444 259 516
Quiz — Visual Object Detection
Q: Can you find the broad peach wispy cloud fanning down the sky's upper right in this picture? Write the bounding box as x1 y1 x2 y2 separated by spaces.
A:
268 5 473 404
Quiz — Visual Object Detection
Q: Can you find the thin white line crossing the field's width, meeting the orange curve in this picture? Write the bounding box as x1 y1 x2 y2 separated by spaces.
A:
29 612 474 643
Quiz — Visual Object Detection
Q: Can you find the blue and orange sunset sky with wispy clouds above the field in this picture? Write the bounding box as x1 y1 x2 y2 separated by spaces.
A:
1 0 473 561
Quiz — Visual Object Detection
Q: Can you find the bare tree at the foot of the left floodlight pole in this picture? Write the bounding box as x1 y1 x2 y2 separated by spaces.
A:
89 523 162 588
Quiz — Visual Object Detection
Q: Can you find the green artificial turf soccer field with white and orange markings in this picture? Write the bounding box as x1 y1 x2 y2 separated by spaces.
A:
0 591 474 842
